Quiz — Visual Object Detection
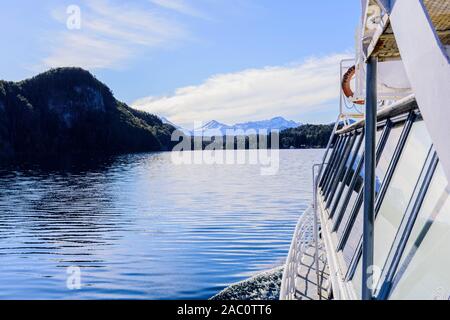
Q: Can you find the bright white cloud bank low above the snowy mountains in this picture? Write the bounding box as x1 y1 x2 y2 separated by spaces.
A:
133 53 351 127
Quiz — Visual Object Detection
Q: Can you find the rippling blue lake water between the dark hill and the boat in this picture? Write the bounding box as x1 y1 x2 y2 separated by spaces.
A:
0 150 323 299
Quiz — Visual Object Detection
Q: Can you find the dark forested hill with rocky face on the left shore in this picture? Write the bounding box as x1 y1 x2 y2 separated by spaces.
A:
0 68 174 156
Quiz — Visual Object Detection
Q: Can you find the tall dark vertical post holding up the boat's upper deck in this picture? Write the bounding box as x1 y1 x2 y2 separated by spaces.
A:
362 57 377 300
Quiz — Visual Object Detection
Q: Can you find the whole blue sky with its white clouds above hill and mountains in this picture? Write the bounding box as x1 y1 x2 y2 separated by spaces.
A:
0 0 360 126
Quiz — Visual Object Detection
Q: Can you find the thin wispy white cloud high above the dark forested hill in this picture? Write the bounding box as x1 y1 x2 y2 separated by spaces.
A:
43 0 193 69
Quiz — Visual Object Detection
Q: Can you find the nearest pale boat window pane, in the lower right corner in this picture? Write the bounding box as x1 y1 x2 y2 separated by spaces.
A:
390 166 450 300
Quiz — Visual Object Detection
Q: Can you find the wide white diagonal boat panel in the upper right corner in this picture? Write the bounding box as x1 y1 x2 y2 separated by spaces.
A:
390 0 450 178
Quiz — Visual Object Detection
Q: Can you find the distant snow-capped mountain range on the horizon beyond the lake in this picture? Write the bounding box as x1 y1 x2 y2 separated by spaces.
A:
161 117 302 137
